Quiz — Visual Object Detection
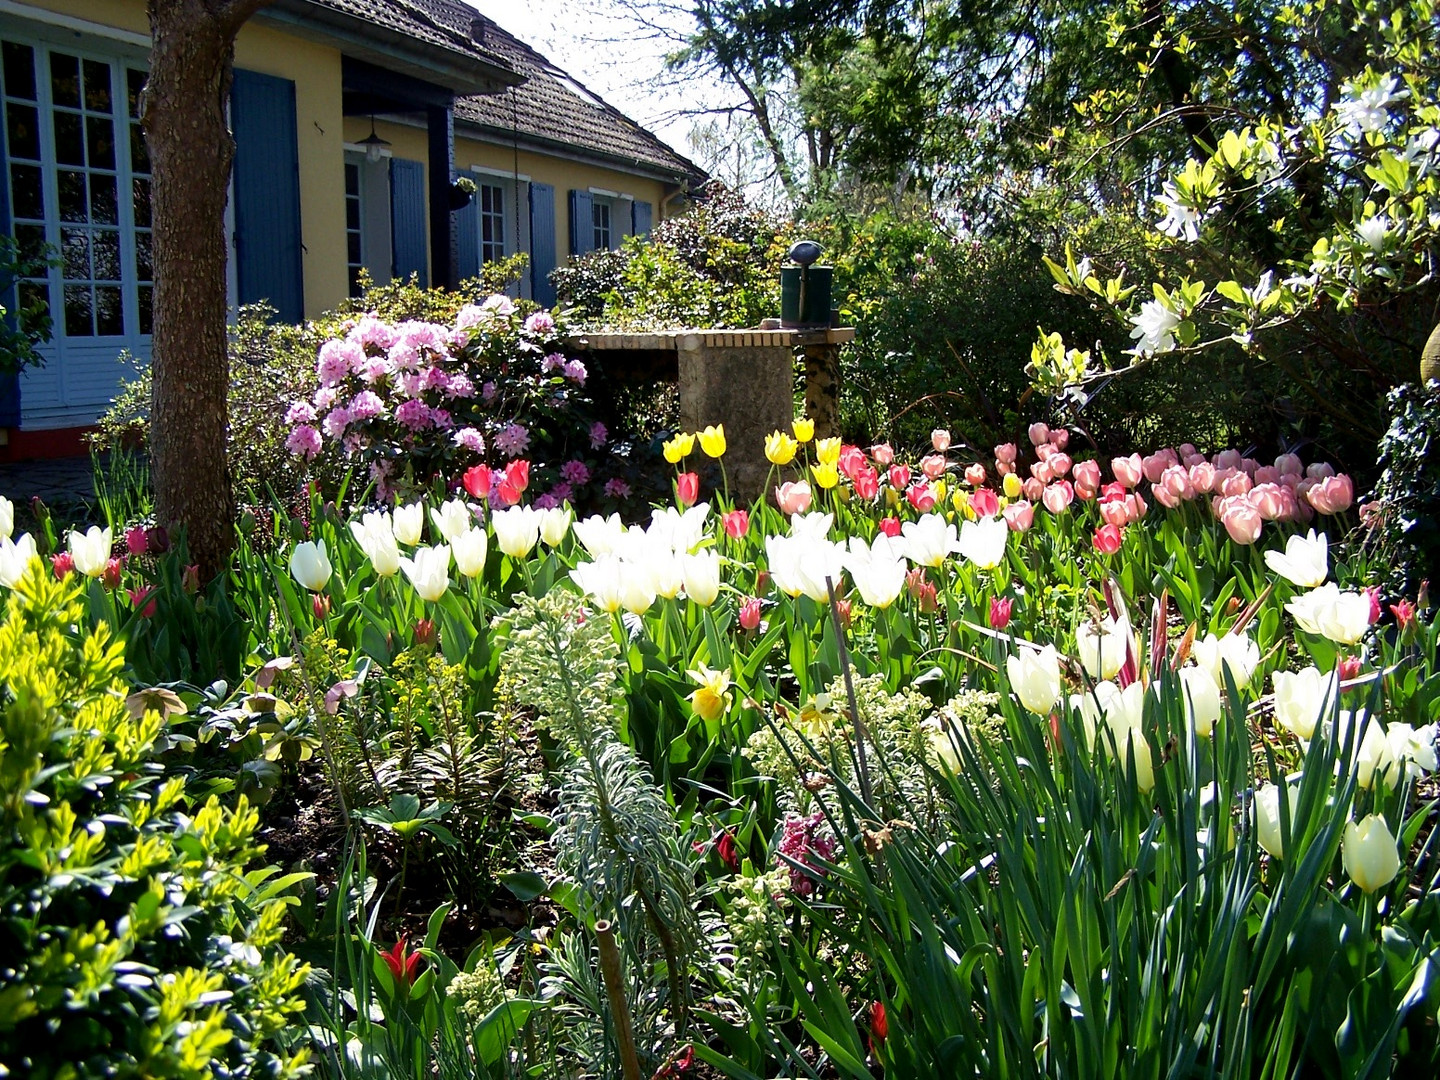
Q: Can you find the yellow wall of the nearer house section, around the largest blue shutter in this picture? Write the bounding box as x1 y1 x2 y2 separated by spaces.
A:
12 0 347 318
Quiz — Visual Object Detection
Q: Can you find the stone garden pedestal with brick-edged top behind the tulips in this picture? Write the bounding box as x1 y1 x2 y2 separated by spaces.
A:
569 328 855 501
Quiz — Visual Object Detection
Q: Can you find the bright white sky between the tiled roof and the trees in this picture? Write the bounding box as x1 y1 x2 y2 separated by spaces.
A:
467 0 723 154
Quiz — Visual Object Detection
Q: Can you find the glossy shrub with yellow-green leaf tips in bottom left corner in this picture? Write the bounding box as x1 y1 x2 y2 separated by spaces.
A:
0 563 307 1080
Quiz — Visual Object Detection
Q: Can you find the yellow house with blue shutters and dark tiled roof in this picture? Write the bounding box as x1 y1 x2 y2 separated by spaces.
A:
0 0 704 458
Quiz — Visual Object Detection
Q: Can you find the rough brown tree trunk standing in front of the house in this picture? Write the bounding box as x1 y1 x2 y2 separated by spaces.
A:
141 0 268 579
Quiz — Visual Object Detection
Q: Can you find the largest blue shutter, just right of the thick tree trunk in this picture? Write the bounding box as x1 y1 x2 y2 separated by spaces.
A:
230 69 305 323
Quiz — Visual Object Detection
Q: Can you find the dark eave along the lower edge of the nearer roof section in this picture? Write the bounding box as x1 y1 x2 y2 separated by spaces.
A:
256 0 524 96
